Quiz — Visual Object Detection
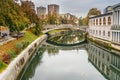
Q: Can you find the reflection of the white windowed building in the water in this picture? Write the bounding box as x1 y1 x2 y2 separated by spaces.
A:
87 43 120 80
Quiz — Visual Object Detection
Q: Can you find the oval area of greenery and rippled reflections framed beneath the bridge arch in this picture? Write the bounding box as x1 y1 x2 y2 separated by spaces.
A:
47 29 85 45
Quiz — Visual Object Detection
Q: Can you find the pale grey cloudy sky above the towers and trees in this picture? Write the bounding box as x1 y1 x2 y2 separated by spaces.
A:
32 0 120 17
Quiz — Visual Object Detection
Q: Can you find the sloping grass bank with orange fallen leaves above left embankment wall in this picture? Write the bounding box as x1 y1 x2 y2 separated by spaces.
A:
0 31 38 72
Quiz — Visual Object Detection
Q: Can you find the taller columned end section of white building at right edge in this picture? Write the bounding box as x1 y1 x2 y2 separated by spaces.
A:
111 3 120 44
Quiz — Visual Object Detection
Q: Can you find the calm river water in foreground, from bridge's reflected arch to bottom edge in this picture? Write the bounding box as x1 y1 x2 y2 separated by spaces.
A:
19 29 120 80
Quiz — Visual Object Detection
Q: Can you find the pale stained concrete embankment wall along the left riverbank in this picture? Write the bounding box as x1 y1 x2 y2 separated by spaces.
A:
0 35 47 80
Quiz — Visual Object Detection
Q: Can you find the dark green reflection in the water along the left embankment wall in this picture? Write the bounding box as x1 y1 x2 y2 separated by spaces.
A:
18 46 46 80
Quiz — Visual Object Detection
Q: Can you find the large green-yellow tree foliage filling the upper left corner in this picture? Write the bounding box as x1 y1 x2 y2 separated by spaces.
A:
0 0 29 32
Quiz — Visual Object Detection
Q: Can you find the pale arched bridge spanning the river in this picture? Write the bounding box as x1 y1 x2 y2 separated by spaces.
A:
43 24 87 33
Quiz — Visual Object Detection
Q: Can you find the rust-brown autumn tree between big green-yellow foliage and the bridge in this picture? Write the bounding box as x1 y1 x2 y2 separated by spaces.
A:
21 1 43 35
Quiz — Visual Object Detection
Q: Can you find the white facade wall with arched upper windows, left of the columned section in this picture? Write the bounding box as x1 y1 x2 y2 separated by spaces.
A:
89 14 112 41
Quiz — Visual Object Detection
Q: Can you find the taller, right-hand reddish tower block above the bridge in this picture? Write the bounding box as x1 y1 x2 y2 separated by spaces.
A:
48 4 59 15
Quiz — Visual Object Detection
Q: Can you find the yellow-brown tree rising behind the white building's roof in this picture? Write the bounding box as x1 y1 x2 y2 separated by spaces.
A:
83 8 101 25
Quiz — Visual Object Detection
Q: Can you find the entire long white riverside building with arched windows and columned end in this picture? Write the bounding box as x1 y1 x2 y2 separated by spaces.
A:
88 3 120 44
